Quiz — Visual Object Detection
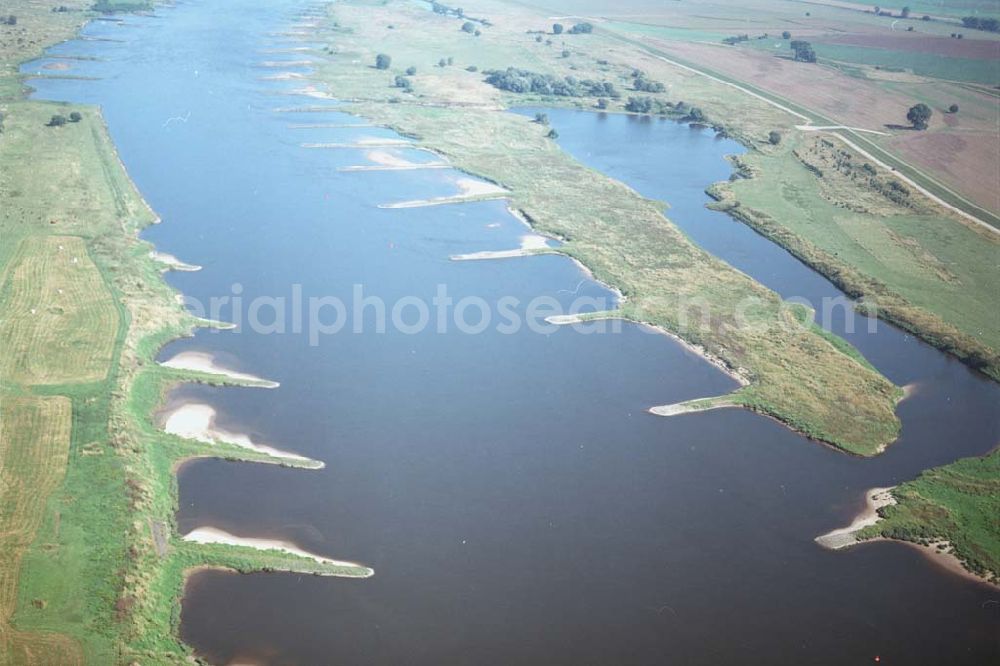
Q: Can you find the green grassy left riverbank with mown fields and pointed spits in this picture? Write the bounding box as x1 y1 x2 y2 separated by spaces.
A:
0 9 371 664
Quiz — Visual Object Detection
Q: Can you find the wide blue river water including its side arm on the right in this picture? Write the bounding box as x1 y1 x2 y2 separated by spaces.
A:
29 0 1000 665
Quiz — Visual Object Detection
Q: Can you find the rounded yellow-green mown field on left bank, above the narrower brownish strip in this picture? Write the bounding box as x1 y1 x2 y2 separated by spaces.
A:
0 236 119 385
